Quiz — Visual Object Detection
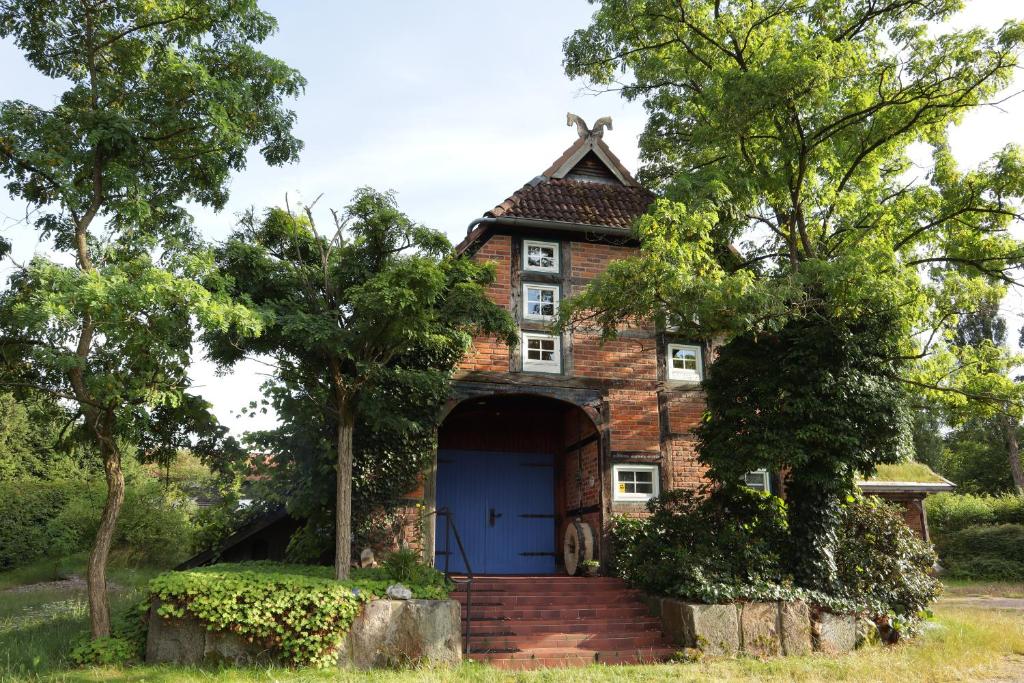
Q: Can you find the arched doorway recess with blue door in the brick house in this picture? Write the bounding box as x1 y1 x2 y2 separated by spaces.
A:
435 394 600 574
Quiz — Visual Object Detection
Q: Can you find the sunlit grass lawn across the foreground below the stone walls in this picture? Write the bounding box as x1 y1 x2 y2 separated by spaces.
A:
0 569 1024 683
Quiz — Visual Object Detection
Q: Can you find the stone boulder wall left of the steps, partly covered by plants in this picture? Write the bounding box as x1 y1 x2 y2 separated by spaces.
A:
145 600 462 669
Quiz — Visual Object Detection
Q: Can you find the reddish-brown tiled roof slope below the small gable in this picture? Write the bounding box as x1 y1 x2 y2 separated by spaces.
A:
485 176 654 228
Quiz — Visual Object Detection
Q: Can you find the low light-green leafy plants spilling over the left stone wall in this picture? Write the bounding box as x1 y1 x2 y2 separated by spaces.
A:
150 562 449 667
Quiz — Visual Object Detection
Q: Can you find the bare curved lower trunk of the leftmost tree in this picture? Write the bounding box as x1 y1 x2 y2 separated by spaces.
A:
86 422 125 638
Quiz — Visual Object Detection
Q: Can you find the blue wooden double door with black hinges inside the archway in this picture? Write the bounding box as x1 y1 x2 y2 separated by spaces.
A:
435 451 555 573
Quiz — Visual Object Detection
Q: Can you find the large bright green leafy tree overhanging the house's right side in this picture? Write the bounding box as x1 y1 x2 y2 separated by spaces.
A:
562 0 1024 581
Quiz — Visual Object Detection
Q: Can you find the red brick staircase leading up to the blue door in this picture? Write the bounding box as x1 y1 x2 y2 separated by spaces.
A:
453 577 678 669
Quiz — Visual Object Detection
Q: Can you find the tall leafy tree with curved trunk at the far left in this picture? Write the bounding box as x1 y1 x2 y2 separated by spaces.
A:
0 0 303 637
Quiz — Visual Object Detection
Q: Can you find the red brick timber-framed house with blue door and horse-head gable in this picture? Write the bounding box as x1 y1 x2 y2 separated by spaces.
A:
422 122 729 574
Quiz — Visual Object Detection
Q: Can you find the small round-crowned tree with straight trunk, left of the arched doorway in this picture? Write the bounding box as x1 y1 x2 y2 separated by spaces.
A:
210 188 516 580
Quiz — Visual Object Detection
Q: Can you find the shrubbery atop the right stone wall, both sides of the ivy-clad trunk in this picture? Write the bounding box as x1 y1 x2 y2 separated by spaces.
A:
611 489 939 620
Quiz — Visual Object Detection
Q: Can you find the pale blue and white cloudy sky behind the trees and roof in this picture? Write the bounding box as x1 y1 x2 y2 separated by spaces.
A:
0 0 1024 433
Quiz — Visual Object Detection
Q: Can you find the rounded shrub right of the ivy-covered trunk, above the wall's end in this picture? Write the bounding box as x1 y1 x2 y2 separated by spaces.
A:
836 498 940 616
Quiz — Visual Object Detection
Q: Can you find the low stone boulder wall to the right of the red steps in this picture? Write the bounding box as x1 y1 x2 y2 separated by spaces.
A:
660 598 856 656
